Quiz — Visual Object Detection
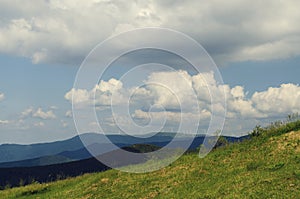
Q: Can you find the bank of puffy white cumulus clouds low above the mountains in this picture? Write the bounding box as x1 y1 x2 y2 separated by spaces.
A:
65 70 300 128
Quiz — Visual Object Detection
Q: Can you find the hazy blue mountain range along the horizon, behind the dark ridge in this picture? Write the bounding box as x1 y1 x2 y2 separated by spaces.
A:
0 133 248 168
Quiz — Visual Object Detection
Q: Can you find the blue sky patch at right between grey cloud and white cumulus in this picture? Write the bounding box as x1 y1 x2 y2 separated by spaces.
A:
219 57 300 94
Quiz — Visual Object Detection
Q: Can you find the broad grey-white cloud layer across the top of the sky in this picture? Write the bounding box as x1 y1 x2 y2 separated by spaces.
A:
0 0 300 64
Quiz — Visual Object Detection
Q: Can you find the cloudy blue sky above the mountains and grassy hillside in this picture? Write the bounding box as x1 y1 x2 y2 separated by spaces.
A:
0 0 300 144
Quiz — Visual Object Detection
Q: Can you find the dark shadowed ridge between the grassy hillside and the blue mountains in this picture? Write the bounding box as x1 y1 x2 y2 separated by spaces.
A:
0 144 160 188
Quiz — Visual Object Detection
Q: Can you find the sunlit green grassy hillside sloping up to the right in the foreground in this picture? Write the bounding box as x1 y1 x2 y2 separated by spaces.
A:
0 121 300 198
